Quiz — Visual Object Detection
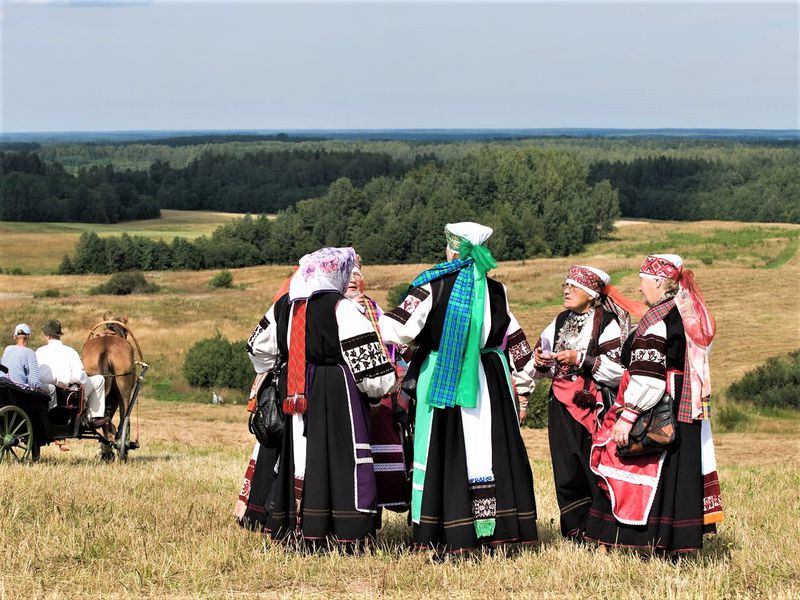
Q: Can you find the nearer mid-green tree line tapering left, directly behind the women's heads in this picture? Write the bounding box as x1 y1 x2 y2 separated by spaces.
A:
60 148 619 273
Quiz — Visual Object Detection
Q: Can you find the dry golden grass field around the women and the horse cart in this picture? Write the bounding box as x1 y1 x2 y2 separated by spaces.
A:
0 222 800 599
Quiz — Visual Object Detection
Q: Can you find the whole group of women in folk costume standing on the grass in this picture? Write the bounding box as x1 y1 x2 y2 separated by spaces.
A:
235 223 722 553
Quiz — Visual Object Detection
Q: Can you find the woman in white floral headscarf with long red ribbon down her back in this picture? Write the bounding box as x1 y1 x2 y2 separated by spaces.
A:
244 248 396 545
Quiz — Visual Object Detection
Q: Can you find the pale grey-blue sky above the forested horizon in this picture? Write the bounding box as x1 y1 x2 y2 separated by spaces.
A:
0 0 800 132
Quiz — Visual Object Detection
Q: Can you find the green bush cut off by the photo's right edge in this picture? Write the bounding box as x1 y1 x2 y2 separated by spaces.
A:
728 350 800 408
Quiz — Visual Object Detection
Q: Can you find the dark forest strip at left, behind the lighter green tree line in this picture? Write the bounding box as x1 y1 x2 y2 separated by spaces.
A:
0 150 409 223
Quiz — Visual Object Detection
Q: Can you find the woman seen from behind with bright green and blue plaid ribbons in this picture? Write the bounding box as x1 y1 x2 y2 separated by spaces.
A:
380 223 538 552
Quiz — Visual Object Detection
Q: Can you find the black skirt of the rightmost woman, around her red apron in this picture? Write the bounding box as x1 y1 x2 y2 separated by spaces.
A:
586 421 704 552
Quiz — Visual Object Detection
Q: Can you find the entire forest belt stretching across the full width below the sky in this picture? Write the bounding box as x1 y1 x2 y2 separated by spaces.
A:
0 136 800 272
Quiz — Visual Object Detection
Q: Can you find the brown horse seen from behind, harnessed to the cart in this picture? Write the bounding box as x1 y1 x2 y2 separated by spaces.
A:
81 314 136 460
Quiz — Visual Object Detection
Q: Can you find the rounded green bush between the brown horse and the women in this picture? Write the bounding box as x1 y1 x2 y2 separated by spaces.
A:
183 332 253 391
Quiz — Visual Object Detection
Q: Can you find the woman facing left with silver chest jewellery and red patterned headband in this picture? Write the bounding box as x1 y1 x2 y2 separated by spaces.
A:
534 265 645 541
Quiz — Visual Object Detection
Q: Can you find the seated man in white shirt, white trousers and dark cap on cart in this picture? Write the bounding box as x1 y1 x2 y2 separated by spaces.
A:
36 319 107 427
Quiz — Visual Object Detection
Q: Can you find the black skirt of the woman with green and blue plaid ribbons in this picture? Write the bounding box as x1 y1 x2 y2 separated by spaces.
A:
413 353 538 552
